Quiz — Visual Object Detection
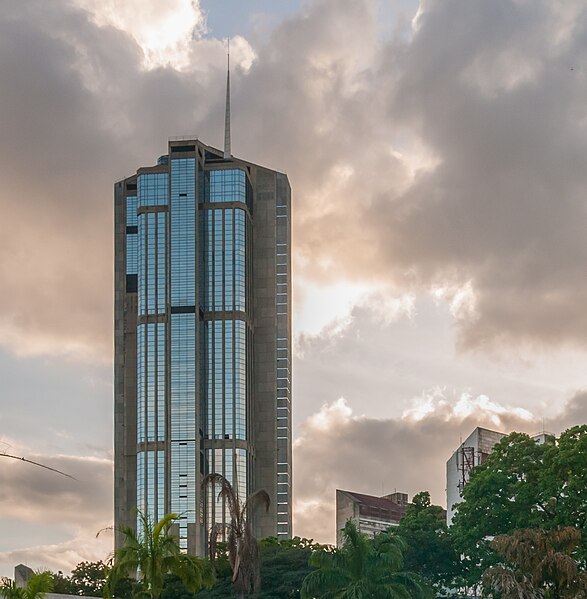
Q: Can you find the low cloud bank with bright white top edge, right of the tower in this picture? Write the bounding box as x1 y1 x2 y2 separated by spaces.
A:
294 389 587 543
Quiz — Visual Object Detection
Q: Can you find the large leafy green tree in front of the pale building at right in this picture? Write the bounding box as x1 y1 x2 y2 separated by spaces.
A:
451 426 587 584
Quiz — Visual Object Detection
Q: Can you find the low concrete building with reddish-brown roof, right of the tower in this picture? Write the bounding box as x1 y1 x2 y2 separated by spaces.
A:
336 489 409 546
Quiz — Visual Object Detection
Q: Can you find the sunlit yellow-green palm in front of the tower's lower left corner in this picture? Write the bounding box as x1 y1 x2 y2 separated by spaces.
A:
107 512 214 599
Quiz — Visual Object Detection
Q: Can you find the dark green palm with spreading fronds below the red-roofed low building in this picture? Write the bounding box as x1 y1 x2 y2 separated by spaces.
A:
301 520 432 599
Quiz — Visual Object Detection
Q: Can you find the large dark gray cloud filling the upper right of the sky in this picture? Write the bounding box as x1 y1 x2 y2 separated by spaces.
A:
366 0 587 347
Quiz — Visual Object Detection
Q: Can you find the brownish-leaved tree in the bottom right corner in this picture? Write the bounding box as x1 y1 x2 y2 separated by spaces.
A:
483 527 587 599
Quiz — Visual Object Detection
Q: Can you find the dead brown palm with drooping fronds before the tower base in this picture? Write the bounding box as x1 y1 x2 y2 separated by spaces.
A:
202 474 271 599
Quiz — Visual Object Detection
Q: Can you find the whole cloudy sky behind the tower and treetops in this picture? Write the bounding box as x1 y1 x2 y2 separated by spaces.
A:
0 0 587 575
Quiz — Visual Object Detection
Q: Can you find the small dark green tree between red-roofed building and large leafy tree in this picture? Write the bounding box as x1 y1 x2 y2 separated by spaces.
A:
394 491 461 593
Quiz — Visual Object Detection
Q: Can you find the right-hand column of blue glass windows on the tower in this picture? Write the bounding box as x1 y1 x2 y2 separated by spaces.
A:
199 169 250 525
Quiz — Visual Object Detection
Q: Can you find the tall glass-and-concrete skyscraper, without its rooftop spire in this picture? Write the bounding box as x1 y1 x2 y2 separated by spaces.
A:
115 139 292 555
